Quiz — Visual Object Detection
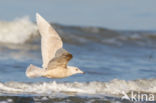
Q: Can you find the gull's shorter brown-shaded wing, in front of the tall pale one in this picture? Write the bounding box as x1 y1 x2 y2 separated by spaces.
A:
47 48 73 69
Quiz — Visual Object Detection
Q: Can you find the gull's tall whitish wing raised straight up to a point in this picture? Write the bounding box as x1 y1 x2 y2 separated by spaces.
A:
36 13 63 69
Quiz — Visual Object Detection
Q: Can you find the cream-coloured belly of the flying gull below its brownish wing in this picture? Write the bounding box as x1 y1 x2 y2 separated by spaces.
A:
43 69 67 78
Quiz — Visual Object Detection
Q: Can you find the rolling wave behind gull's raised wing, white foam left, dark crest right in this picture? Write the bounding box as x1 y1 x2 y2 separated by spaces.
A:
0 17 156 46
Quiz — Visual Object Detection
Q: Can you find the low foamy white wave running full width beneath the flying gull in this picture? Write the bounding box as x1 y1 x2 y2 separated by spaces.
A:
0 79 156 95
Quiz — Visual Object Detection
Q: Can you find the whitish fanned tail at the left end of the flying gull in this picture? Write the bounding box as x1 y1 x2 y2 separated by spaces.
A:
26 64 44 78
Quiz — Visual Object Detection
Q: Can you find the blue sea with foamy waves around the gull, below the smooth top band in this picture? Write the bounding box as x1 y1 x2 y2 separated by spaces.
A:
0 17 156 103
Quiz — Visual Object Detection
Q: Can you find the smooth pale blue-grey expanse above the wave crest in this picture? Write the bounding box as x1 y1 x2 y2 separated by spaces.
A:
0 0 156 30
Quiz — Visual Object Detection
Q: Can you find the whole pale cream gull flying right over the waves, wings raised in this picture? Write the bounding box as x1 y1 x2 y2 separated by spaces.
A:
26 13 84 78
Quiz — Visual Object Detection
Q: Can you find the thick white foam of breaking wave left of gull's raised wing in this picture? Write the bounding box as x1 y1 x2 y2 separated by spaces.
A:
0 17 37 44
